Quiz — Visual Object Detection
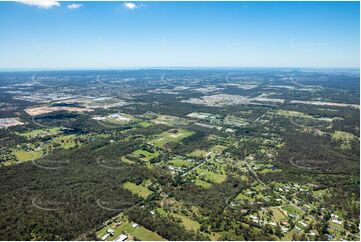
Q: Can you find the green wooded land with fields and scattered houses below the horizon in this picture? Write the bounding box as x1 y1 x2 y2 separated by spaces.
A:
0 69 360 241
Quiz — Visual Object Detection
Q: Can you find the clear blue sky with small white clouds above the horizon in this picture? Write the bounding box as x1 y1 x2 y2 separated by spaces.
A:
0 0 360 69
